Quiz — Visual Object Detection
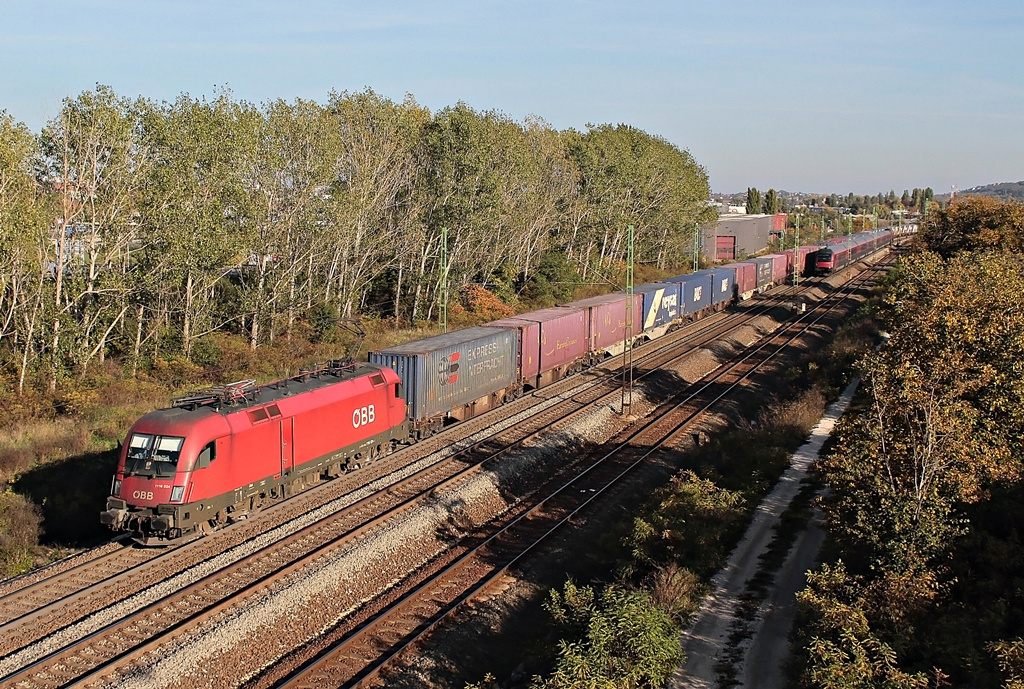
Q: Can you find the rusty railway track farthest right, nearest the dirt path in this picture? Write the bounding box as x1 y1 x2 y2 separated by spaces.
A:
257 247 897 687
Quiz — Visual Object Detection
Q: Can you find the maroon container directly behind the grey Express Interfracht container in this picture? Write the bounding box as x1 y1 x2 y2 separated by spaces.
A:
486 306 588 389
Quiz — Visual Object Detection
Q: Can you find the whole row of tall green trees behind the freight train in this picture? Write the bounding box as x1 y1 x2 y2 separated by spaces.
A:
0 86 714 394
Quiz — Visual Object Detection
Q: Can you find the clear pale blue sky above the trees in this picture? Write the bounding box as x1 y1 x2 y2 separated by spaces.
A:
0 0 1024 193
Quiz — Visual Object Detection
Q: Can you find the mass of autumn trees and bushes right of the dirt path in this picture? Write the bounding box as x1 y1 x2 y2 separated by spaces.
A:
801 199 1024 687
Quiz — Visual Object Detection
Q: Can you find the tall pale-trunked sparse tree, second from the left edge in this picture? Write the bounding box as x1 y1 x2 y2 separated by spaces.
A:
37 86 152 380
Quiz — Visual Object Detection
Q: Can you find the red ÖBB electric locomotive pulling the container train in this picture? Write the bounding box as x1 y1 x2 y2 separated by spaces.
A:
100 360 409 545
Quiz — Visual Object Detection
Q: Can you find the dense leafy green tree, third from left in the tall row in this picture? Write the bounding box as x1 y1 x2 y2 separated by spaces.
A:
141 92 252 356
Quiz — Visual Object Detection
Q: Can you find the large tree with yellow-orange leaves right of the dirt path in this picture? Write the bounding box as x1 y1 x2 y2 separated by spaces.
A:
822 247 1024 568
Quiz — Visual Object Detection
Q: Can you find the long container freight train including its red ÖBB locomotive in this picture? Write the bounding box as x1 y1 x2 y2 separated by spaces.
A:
100 232 892 545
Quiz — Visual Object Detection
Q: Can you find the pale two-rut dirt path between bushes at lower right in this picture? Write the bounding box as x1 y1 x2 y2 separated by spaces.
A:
668 381 859 689
